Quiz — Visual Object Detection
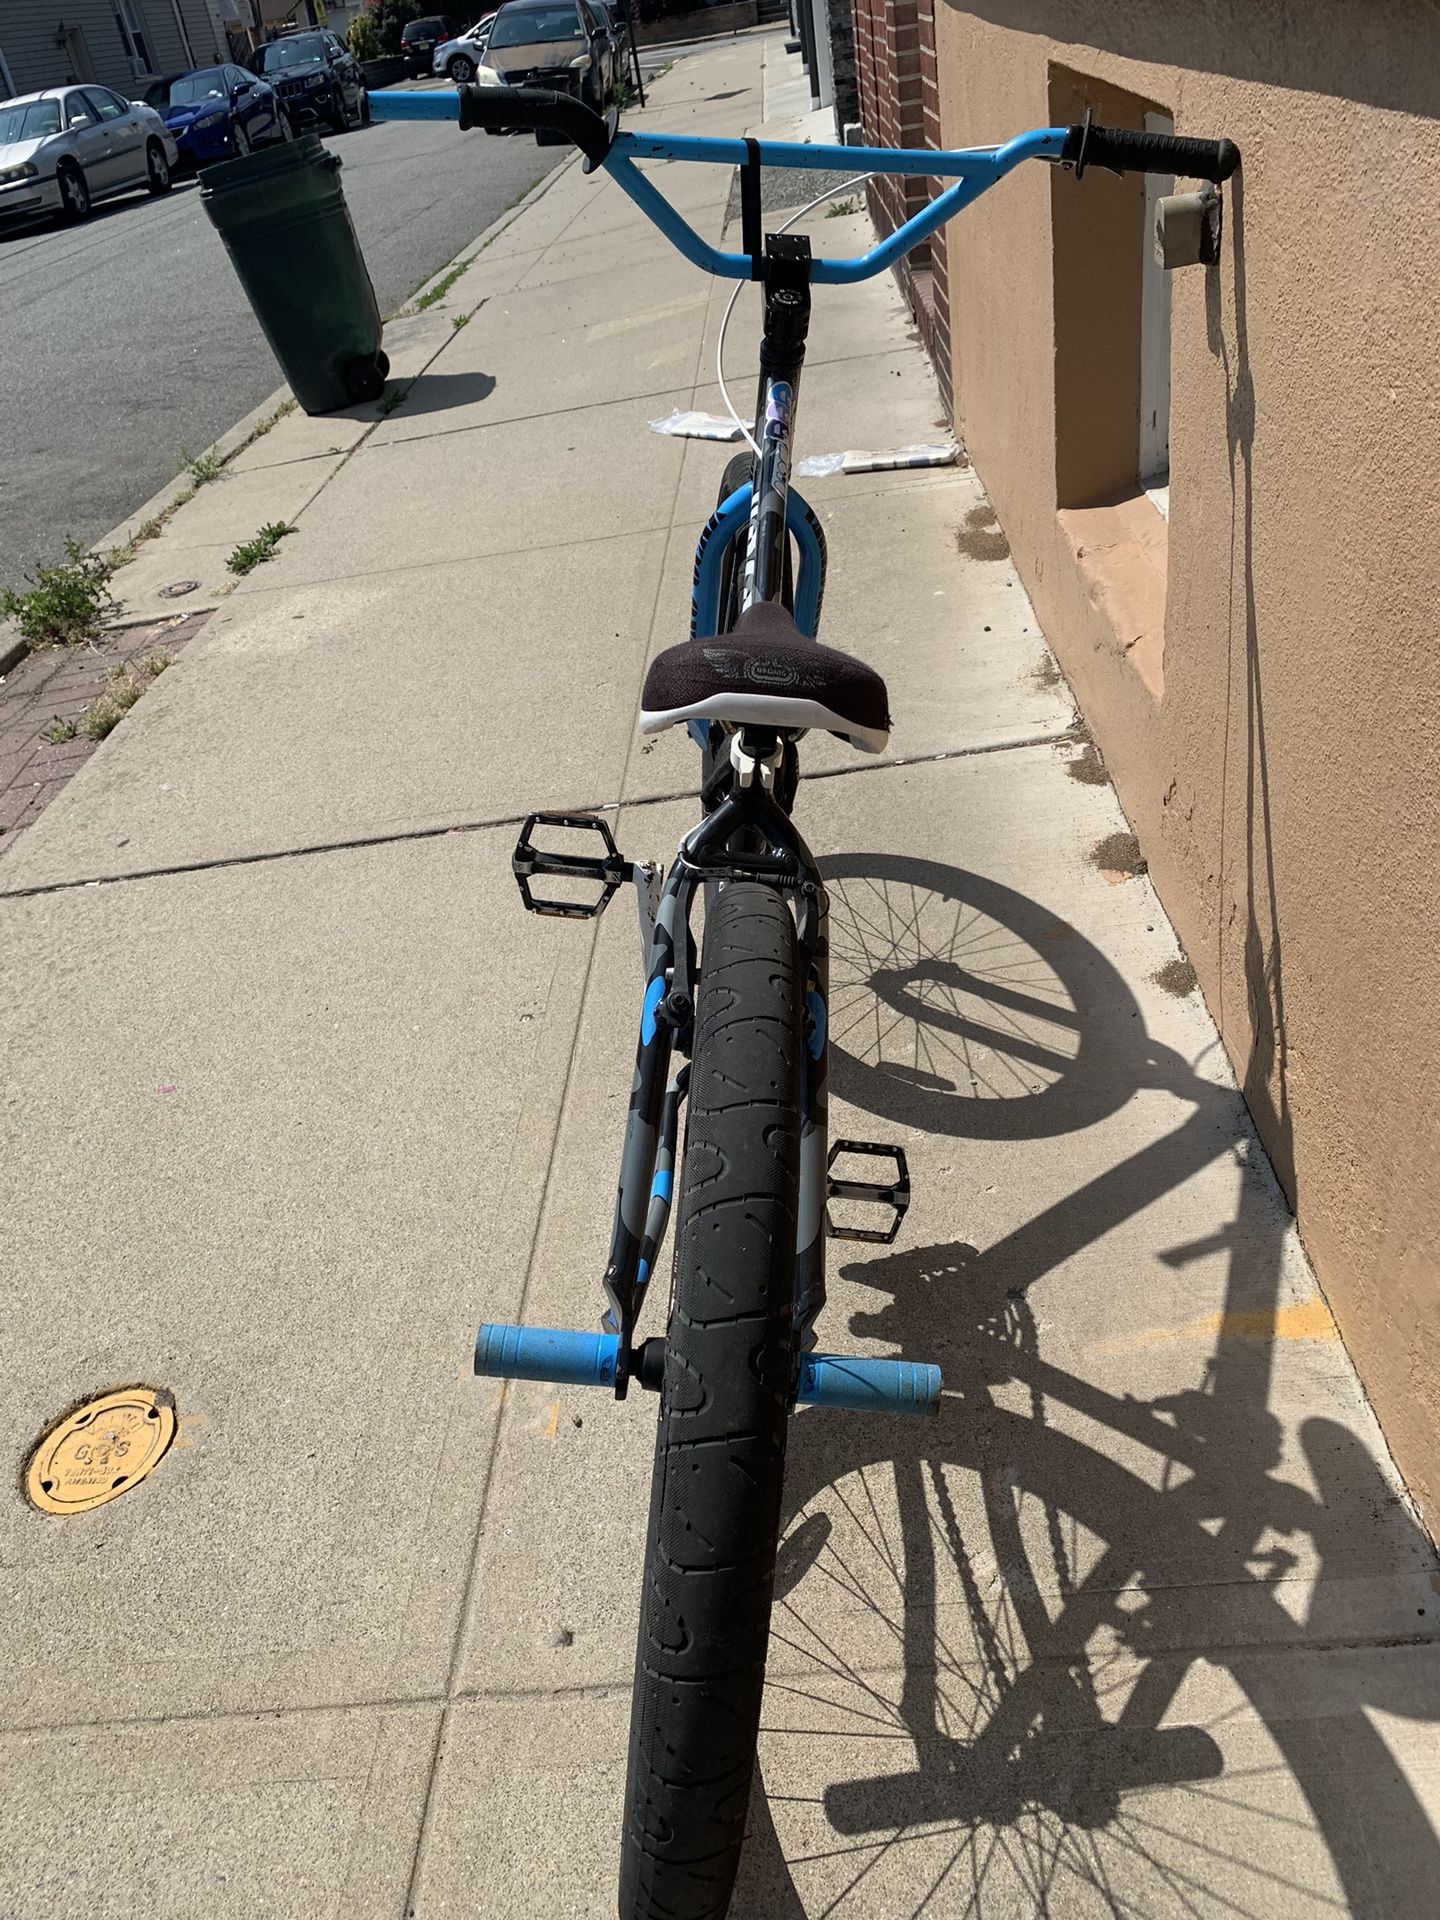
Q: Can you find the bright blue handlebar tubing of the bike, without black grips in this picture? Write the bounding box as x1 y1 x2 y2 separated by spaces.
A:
371 86 1068 286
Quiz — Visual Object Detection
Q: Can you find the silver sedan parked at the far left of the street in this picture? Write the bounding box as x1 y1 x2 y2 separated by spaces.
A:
0 83 177 228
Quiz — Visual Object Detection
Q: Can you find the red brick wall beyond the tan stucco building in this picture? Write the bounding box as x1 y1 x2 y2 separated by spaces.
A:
852 0 952 413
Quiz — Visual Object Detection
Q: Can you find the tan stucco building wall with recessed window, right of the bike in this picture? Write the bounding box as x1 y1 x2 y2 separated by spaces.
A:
937 0 1440 1526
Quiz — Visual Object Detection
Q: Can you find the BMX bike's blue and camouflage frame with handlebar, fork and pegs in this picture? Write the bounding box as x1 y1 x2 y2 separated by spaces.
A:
372 90 1069 1411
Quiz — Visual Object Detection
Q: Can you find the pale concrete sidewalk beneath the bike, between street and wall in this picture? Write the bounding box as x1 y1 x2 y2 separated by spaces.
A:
0 35 1440 1920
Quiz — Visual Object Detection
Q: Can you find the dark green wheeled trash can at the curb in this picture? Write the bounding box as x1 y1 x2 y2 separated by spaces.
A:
200 132 390 413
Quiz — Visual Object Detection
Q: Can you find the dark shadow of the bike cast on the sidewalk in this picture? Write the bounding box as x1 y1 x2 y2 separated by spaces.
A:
732 854 1440 1920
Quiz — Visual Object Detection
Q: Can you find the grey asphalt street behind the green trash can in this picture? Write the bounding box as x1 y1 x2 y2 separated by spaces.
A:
0 123 564 586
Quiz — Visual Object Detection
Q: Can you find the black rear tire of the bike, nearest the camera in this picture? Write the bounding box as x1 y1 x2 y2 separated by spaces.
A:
620 883 803 1920
